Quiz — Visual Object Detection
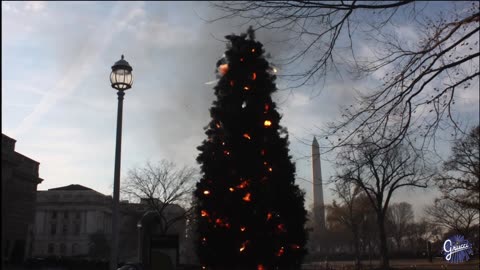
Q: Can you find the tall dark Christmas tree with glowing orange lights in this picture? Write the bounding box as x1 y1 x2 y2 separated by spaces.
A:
195 29 306 269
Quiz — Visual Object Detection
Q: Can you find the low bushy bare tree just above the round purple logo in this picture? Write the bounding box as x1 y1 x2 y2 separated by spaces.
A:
425 199 479 238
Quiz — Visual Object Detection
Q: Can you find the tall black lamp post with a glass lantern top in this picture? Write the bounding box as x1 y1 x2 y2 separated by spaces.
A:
110 55 133 270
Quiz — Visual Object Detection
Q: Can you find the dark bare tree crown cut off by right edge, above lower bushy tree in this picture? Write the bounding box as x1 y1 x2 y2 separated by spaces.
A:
437 126 480 211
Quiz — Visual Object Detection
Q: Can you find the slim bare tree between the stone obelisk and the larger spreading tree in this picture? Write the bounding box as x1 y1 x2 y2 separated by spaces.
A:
329 182 364 269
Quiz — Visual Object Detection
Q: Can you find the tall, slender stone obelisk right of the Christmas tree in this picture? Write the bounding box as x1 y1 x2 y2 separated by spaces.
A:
312 137 325 230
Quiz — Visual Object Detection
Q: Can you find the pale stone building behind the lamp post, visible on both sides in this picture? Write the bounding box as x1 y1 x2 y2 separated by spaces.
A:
32 185 185 262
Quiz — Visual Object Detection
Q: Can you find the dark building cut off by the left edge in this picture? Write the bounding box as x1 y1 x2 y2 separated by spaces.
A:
2 133 43 263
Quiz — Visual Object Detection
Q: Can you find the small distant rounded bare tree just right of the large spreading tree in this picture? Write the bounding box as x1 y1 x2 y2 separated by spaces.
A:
386 202 414 251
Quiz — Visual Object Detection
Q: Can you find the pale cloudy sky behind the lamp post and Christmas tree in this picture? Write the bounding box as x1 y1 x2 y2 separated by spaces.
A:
2 1 479 219
